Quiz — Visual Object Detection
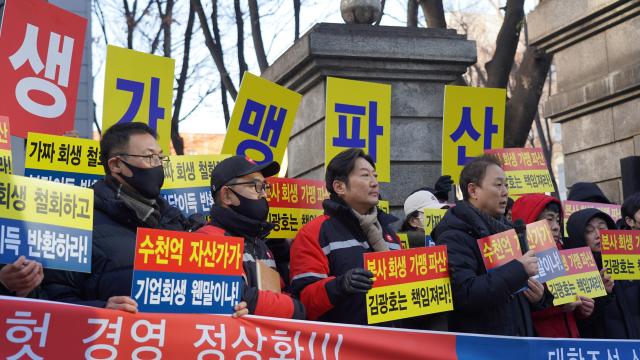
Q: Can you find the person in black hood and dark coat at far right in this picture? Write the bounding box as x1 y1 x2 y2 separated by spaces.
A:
565 209 640 339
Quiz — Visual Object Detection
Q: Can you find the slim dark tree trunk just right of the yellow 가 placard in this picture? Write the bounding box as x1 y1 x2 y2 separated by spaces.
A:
169 0 196 155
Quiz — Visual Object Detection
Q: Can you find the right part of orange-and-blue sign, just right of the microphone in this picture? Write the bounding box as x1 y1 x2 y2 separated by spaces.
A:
527 220 566 283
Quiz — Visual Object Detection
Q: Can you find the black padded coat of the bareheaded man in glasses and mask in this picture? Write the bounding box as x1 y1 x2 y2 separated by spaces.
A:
43 180 191 307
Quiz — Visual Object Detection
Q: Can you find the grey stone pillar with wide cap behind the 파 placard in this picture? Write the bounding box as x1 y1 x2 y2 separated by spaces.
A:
262 23 476 216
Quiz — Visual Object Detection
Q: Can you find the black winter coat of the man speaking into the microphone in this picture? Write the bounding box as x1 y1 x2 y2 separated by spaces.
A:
431 201 548 336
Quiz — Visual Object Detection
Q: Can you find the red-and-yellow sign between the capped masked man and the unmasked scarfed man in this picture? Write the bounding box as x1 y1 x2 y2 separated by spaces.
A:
267 178 329 239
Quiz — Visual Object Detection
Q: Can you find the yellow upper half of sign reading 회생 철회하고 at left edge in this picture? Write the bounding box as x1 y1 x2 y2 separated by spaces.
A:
0 174 93 230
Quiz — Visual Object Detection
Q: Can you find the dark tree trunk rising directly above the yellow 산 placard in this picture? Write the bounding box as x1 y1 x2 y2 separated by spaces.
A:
484 0 533 88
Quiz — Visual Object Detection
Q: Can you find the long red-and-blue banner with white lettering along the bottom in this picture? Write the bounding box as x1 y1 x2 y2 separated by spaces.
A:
0 297 640 360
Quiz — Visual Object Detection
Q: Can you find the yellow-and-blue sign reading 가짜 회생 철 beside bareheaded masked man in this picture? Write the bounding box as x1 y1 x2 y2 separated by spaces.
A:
24 132 104 187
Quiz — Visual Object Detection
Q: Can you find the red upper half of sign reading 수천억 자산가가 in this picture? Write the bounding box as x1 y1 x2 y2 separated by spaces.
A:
134 228 244 275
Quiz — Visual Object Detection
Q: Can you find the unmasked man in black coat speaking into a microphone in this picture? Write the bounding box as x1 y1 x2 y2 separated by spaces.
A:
432 155 547 336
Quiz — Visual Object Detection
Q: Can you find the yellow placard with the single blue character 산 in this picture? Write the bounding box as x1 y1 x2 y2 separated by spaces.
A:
442 85 507 184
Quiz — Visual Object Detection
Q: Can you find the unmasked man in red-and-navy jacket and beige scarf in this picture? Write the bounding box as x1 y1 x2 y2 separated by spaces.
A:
290 149 400 325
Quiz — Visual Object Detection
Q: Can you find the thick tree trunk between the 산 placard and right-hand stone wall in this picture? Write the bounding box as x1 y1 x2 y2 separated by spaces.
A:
504 46 552 147
